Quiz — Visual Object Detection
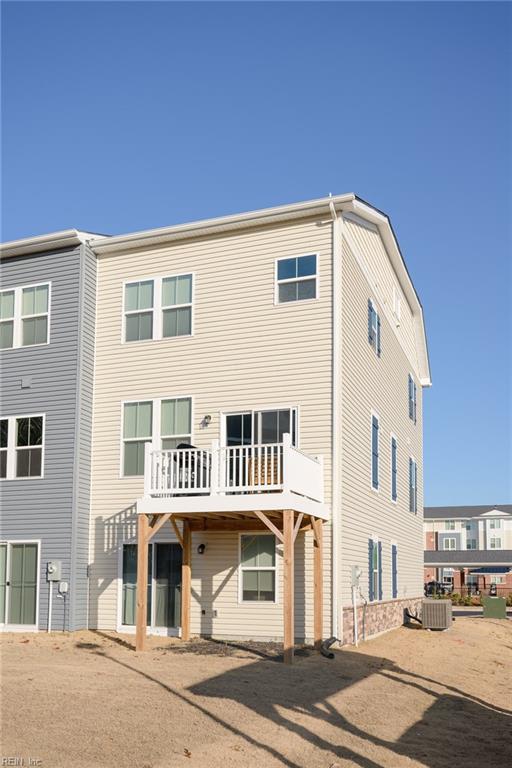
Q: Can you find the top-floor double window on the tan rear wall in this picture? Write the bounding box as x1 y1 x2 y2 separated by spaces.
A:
123 274 193 343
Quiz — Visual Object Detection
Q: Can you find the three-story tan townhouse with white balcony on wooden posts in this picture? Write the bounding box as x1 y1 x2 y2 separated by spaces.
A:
89 195 430 642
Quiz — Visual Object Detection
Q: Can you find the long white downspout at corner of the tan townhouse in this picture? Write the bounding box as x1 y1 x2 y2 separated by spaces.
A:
329 201 343 642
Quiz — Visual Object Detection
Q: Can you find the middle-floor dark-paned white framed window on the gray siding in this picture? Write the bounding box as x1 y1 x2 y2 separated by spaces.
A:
0 414 45 480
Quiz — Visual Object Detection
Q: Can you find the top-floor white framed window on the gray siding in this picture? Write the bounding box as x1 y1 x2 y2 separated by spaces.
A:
0 283 50 349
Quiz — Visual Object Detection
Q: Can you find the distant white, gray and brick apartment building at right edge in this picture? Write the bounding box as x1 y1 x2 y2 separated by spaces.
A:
424 504 512 590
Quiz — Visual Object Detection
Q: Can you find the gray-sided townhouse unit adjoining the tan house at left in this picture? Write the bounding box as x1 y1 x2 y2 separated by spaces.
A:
0 230 96 630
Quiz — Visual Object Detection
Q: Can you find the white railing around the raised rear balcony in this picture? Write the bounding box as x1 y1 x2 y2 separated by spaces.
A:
144 435 324 503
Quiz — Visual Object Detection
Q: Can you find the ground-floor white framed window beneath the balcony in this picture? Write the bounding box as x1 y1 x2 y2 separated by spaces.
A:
239 533 276 603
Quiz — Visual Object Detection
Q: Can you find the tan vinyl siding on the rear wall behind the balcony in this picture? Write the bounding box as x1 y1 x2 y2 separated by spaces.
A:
90 221 332 637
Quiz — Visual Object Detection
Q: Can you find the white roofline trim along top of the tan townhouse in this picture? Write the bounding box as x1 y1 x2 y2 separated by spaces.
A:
89 192 432 386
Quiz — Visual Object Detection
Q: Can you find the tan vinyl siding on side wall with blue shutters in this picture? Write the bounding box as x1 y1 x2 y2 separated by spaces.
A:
341 237 424 605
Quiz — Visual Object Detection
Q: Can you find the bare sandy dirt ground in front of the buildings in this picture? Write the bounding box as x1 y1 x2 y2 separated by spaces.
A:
0 618 512 768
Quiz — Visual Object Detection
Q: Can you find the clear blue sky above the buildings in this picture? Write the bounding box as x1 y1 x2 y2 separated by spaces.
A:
2 2 512 505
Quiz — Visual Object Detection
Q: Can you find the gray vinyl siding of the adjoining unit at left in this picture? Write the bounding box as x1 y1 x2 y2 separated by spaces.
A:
0 248 95 630
